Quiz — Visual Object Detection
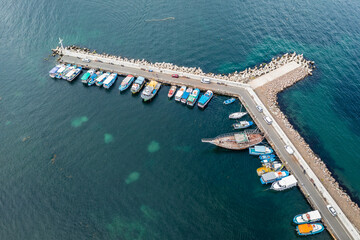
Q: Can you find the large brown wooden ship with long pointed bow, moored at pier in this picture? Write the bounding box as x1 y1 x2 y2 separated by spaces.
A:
201 130 264 150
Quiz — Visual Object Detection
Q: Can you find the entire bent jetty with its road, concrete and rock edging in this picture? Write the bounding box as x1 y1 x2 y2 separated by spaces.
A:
53 43 360 239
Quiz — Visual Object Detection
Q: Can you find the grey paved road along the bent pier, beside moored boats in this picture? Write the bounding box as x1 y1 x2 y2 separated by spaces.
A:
62 56 356 240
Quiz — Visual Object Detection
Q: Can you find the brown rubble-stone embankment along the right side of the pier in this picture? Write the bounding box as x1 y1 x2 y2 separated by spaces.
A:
255 68 360 229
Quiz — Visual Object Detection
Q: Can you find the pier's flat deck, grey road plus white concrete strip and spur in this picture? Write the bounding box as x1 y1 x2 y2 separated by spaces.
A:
57 50 360 240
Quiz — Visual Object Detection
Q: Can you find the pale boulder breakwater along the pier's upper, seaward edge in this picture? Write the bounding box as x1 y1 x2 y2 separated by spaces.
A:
52 46 315 84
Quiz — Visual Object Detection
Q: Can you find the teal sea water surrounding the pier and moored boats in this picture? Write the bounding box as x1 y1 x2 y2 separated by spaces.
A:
0 0 360 239
